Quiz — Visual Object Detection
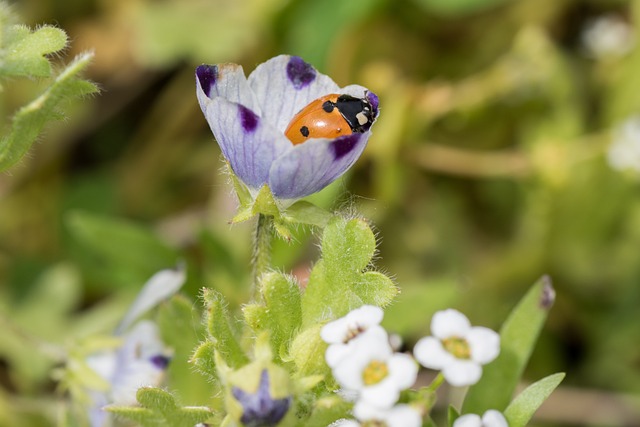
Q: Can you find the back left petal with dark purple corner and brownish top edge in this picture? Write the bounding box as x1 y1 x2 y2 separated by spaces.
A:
196 64 261 115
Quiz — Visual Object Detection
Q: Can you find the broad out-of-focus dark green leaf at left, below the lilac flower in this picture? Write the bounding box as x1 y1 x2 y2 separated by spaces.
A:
66 211 178 287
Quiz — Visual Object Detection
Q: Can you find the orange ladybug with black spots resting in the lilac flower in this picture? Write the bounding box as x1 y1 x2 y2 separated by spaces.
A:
284 94 374 144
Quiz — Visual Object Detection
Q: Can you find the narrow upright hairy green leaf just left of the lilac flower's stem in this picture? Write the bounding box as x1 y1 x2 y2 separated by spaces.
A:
203 288 249 369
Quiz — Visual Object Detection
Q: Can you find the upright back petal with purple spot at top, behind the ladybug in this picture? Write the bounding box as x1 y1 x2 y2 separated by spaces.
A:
249 55 339 132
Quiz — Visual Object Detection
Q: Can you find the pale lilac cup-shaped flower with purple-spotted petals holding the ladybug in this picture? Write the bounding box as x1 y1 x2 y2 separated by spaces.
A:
196 55 378 200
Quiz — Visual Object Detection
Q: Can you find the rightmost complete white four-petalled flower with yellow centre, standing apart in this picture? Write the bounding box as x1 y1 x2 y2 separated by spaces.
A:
413 309 500 387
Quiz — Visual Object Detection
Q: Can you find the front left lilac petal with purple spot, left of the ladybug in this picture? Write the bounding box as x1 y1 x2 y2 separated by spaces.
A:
205 97 291 190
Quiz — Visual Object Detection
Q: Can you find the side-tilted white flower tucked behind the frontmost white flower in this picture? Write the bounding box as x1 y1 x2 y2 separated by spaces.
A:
320 305 386 368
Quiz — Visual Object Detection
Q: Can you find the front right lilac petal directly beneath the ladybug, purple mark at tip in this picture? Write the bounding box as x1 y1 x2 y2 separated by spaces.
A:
269 132 370 199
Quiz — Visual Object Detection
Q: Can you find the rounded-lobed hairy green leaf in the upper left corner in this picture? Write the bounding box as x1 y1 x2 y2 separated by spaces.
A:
0 25 67 77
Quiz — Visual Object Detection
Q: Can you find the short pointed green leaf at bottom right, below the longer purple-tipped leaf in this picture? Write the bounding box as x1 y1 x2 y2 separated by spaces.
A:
504 373 565 427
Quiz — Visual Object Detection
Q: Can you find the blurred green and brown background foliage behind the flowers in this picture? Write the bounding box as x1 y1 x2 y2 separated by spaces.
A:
0 0 640 426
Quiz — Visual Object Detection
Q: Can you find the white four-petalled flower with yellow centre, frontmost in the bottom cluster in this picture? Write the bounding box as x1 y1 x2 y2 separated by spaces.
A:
333 328 418 408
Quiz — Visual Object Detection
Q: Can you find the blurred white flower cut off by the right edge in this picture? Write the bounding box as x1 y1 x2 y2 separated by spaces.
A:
607 116 640 173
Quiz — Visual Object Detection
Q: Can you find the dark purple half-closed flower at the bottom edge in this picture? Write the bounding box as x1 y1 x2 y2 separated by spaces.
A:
232 369 291 427
